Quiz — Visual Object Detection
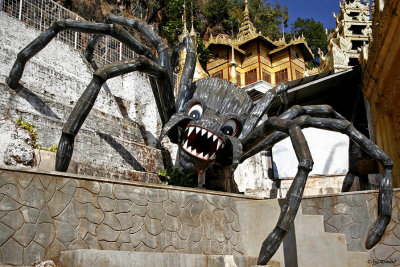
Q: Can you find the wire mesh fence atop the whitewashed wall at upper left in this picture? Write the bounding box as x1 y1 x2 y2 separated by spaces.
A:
0 0 135 65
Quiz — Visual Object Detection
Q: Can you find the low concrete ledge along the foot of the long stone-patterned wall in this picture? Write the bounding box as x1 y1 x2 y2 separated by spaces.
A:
61 249 260 267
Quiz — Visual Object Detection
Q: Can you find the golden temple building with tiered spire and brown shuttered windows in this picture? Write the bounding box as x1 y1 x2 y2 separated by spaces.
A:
205 0 314 91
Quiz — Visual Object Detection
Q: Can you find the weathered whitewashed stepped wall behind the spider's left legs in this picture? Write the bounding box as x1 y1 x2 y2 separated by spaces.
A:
0 12 164 179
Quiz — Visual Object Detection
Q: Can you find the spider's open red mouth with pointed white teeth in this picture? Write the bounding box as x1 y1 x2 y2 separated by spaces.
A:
182 125 225 160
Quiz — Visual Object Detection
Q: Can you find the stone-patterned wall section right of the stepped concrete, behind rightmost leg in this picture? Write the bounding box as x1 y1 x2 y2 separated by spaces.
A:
301 189 400 266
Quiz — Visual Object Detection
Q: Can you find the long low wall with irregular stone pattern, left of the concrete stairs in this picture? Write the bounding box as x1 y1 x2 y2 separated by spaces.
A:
0 167 250 265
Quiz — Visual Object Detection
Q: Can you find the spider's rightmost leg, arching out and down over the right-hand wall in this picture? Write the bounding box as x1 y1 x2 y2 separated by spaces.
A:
242 105 393 255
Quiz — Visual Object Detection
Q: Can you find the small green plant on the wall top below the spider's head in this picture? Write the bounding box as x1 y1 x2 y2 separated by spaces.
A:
157 169 197 187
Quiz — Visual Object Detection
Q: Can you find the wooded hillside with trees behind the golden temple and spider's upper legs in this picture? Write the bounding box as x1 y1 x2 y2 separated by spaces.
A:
57 0 326 64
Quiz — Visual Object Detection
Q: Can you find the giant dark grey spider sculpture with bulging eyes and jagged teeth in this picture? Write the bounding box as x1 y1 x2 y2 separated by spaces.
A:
7 16 393 264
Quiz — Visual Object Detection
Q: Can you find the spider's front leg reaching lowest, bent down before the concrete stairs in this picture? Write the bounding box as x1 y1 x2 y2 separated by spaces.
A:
242 117 313 265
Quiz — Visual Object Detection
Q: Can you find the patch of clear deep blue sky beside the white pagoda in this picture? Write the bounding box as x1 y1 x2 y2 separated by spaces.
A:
280 0 339 31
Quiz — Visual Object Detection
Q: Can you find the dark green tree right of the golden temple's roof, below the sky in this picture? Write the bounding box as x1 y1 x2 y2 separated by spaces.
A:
291 18 327 66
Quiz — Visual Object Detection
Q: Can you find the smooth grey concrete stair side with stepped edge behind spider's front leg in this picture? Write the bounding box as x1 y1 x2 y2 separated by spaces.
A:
237 199 370 267
